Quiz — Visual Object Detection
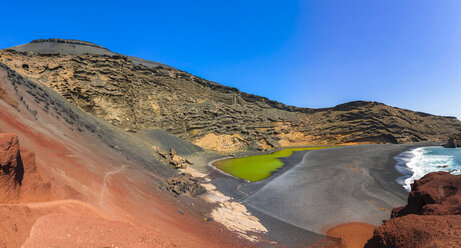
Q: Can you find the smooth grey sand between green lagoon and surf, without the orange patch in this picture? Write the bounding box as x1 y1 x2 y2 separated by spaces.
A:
243 143 427 246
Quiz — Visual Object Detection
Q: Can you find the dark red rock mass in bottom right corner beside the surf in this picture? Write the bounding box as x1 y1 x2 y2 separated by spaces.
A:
365 172 461 248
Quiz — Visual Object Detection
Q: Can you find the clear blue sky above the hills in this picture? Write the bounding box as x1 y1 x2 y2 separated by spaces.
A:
0 0 461 119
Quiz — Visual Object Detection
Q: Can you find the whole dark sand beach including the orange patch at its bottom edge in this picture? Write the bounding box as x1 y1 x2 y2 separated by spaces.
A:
193 144 434 247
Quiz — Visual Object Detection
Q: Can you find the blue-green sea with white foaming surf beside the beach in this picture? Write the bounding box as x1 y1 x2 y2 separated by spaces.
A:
395 146 461 191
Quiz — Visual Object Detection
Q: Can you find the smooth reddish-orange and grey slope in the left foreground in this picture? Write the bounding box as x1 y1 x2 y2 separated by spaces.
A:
0 57 245 248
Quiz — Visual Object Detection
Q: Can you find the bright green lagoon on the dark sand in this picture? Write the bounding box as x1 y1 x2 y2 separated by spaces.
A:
213 147 328 182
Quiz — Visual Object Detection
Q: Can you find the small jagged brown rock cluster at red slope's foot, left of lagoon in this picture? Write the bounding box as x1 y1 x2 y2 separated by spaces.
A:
165 173 206 197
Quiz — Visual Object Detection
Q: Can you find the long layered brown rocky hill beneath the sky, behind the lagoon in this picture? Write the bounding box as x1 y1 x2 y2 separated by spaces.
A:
0 39 461 150
